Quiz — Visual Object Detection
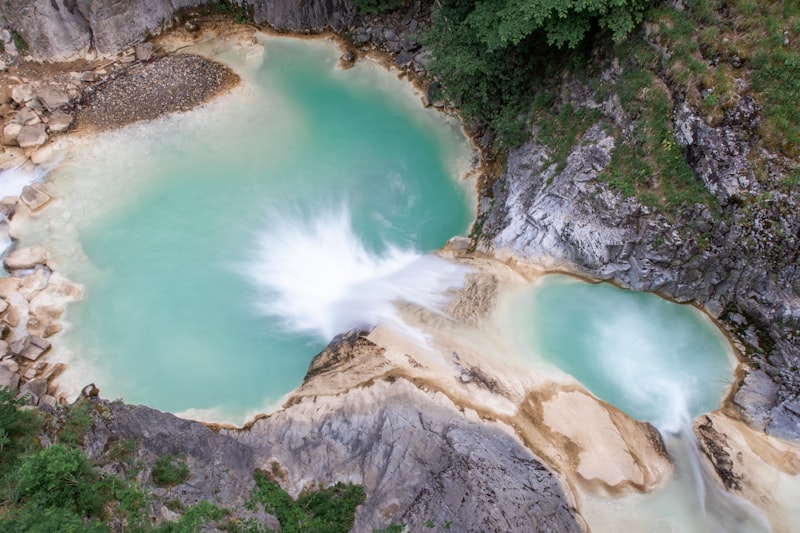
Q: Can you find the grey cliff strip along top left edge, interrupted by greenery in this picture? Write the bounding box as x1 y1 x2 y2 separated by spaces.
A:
0 0 356 61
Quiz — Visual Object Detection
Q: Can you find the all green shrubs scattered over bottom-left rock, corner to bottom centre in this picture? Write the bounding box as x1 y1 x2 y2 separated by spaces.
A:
0 388 364 533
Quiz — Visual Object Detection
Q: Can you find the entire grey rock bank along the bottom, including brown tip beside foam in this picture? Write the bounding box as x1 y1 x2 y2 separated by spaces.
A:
54 326 585 533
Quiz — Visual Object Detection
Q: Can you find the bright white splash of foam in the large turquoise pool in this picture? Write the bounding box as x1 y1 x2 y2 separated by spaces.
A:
241 207 468 340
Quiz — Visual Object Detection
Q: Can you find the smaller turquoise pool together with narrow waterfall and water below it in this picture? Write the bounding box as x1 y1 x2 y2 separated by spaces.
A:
518 275 771 533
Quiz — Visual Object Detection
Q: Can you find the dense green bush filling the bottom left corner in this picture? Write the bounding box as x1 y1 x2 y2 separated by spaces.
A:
0 389 146 533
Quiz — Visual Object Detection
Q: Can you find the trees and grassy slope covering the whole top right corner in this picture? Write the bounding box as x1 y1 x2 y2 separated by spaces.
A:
424 0 800 215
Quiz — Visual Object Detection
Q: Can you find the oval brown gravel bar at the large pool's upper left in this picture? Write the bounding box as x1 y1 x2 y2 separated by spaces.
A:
75 54 239 131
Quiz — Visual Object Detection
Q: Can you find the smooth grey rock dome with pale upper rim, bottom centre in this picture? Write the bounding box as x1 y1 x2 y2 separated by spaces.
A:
230 379 583 532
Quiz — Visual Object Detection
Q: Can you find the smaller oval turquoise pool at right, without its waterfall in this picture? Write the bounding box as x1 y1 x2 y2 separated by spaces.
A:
517 275 734 432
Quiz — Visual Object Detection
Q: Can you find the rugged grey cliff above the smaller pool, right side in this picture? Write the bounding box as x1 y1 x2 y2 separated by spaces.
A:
480 87 800 439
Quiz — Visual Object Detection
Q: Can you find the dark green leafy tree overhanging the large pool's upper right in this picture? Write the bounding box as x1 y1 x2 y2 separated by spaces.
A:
423 0 648 146
